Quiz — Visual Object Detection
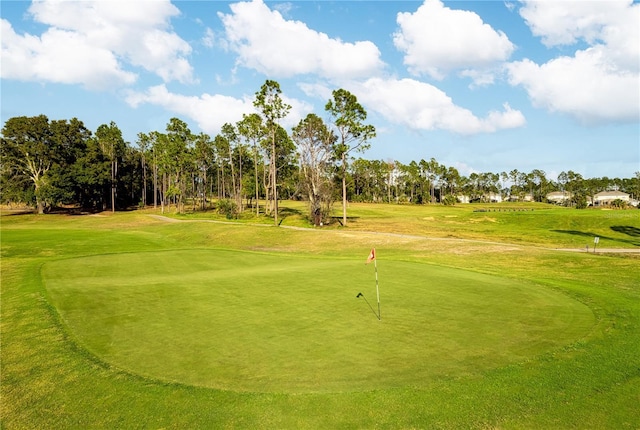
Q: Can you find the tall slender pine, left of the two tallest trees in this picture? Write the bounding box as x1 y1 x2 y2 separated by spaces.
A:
253 80 291 225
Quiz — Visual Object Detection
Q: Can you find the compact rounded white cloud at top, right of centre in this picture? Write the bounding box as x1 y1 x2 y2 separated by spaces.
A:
393 0 514 79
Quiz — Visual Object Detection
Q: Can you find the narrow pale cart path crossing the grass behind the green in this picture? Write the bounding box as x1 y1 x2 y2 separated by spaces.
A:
149 215 640 254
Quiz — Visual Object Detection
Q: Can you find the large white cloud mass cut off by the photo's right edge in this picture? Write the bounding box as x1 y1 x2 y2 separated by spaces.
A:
506 0 640 124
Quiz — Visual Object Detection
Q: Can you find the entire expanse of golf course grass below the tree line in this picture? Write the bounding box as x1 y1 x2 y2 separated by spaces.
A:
0 202 640 429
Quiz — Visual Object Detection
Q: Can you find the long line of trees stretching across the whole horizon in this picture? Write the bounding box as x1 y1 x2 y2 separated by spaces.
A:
0 80 640 225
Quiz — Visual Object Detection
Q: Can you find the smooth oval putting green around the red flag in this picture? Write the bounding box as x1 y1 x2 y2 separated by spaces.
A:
42 249 594 393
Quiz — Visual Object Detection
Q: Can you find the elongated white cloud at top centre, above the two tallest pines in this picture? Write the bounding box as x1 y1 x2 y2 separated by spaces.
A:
219 0 383 78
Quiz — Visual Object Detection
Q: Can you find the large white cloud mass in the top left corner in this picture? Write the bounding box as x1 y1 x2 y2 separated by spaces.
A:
2 0 193 88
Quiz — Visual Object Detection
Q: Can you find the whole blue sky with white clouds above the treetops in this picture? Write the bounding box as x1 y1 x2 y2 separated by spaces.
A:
0 0 640 179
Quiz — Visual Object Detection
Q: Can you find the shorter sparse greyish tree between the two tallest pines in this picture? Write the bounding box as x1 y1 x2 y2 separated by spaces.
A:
292 113 336 225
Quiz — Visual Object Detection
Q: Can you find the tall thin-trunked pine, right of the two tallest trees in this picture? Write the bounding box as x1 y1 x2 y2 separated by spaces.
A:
325 88 376 226
